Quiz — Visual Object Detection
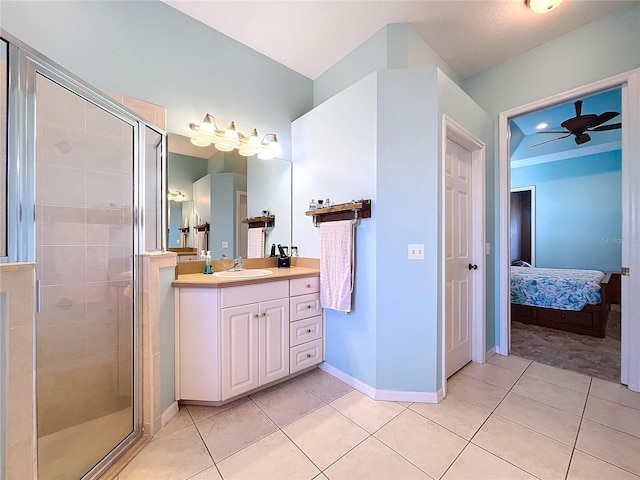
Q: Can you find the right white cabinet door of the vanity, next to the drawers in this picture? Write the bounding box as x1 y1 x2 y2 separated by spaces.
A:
260 298 289 385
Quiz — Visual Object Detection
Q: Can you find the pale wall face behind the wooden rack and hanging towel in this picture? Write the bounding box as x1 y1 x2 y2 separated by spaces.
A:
291 73 378 386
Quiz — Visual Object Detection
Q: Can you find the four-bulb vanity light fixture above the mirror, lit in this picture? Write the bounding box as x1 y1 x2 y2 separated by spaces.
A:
189 113 282 160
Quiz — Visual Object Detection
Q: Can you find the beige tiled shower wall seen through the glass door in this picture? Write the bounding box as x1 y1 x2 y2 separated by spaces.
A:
36 77 133 437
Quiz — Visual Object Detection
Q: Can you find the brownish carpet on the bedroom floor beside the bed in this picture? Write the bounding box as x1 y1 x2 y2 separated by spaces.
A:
511 305 620 383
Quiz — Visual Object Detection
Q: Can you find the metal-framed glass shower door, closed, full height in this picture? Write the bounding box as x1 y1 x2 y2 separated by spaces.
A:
32 68 144 480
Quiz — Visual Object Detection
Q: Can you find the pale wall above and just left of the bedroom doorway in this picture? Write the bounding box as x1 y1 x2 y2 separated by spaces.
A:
461 2 640 345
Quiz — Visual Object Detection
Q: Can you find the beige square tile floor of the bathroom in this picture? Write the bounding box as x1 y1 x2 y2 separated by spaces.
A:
118 355 640 480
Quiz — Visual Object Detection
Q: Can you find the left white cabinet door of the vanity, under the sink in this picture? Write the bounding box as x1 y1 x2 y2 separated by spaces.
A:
221 304 260 400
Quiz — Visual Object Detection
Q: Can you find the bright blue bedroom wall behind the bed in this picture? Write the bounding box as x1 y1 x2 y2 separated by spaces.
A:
511 150 622 271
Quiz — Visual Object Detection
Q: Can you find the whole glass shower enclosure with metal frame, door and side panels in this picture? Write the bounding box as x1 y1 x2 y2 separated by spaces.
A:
3 34 166 480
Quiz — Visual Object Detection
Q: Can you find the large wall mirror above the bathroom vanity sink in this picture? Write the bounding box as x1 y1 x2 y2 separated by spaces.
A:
167 133 291 259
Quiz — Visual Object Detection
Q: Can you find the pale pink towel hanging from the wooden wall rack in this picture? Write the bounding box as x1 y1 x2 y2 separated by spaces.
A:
320 220 354 313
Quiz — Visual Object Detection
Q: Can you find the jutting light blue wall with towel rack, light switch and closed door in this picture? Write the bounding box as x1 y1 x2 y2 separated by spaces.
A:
293 68 493 392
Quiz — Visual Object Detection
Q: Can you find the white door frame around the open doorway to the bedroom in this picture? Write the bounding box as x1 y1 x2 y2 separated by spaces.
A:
496 68 640 391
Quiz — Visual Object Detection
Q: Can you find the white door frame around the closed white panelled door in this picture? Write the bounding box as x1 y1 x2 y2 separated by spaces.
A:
439 115 487 396
